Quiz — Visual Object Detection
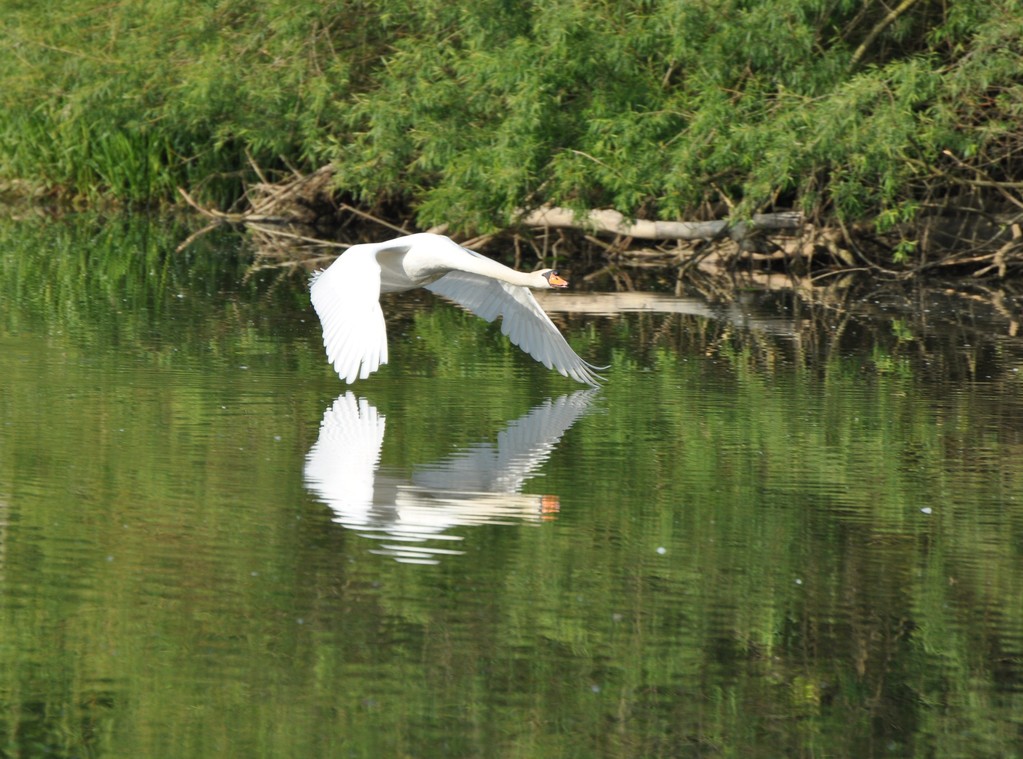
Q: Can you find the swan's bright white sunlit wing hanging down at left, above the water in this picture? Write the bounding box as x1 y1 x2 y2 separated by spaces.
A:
309 248 387 383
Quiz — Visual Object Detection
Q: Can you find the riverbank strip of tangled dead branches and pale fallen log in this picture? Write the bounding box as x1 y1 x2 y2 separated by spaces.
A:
175 166 1023 293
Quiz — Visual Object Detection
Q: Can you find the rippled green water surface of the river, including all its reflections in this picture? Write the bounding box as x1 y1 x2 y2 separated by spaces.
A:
0 218 1023 757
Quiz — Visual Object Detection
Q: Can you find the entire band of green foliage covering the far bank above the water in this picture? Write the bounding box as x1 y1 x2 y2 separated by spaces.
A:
0 0 1023 245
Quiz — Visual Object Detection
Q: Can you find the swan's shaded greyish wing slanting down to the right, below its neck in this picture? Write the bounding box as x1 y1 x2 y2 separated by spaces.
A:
426 271 601 387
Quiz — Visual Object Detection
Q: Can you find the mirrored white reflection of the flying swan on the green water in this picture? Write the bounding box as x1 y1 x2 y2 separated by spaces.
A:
305 390 597 564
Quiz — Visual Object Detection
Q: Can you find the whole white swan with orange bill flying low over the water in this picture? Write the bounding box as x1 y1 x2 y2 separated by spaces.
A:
310 233 601 387
